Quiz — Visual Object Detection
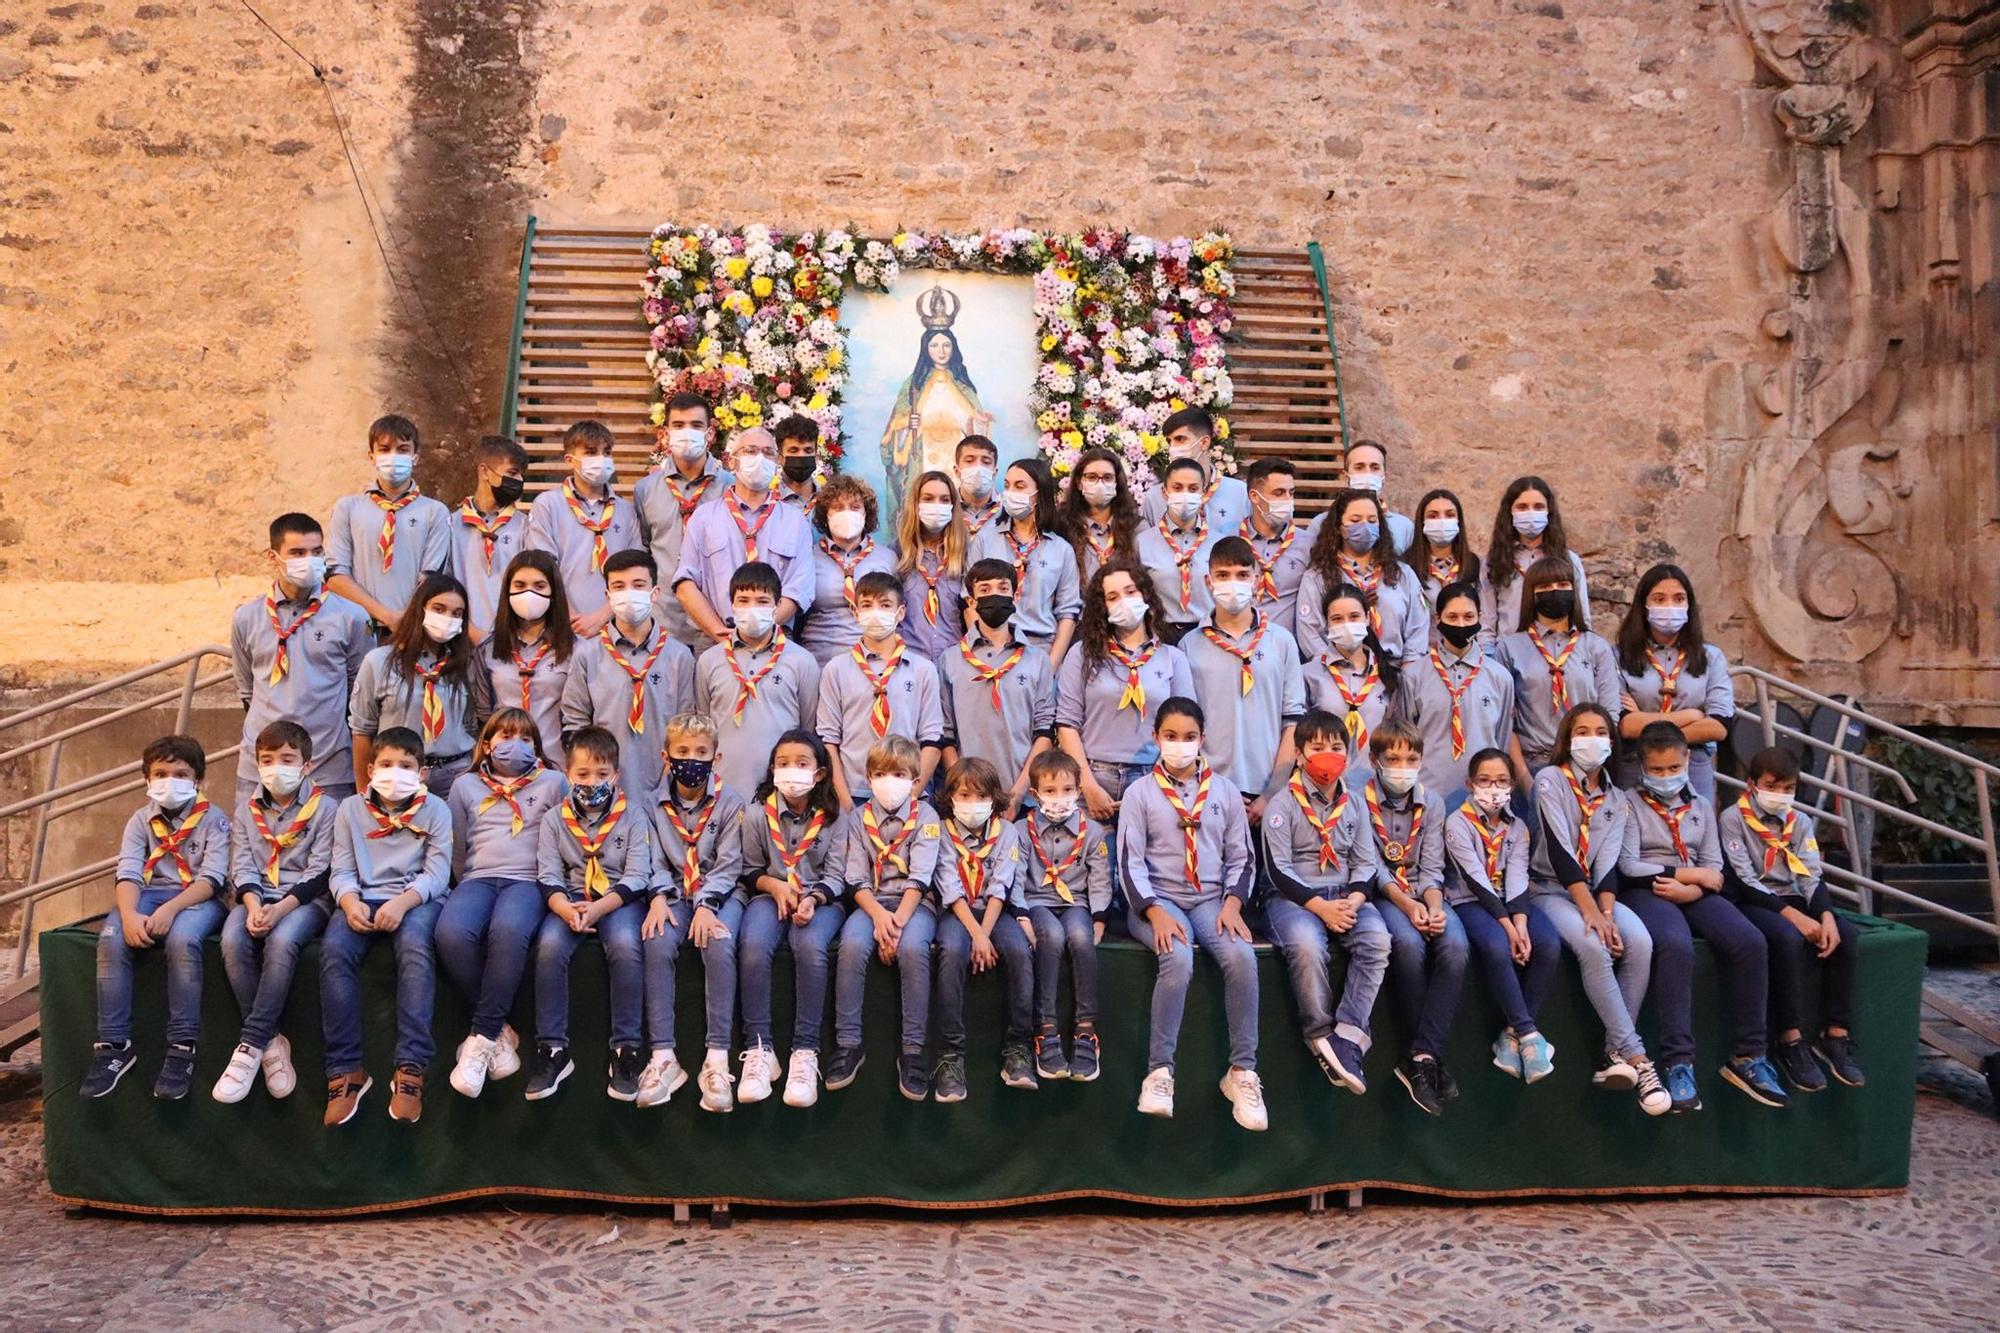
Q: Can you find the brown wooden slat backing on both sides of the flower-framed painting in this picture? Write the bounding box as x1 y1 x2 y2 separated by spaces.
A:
514 226 1342 512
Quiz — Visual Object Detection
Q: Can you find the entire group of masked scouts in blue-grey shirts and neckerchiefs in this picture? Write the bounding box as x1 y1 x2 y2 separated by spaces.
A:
82 394 1862 1129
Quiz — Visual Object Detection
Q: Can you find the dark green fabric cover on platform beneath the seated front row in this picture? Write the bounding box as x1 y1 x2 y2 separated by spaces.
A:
42 921 1924 1213
